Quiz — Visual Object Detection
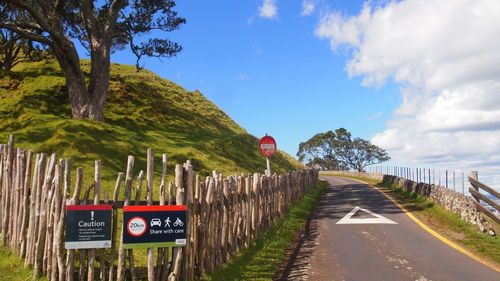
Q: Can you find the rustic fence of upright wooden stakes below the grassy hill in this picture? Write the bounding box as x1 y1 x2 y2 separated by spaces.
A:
0 136 318 281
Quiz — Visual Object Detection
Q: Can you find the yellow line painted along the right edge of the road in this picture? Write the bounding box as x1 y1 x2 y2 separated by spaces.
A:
346 177 500 272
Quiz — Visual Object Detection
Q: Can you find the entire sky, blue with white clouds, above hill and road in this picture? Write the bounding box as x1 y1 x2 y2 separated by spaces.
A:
97 0 500 186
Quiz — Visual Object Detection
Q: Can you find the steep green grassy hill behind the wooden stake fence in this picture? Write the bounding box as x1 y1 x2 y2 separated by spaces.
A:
0 60 303 189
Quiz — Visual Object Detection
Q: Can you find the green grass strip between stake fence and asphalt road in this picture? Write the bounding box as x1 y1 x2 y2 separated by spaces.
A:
206 181 326 281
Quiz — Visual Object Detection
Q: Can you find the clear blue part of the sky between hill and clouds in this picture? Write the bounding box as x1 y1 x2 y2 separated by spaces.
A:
105 1 399 156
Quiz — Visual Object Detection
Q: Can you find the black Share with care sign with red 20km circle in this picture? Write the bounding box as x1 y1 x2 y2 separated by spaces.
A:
123 205 187 249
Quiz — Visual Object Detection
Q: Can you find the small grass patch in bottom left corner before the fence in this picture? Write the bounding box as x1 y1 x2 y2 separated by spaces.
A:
0 246 47 281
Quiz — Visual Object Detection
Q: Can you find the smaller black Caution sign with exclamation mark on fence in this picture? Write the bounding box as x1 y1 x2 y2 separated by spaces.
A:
65 205 113 249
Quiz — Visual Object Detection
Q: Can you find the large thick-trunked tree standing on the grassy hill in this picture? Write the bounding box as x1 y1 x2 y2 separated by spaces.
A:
0 0 186 121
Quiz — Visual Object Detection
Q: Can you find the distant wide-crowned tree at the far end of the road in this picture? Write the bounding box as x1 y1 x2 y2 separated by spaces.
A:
297 128 390 172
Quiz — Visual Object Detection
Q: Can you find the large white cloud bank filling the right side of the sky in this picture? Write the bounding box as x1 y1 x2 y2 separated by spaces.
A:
315 0 500 188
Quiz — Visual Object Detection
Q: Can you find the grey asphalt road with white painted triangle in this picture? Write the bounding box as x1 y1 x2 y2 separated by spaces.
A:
287 177 500 281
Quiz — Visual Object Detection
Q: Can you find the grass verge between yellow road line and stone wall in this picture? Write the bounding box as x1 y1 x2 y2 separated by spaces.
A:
330 176 500 265
